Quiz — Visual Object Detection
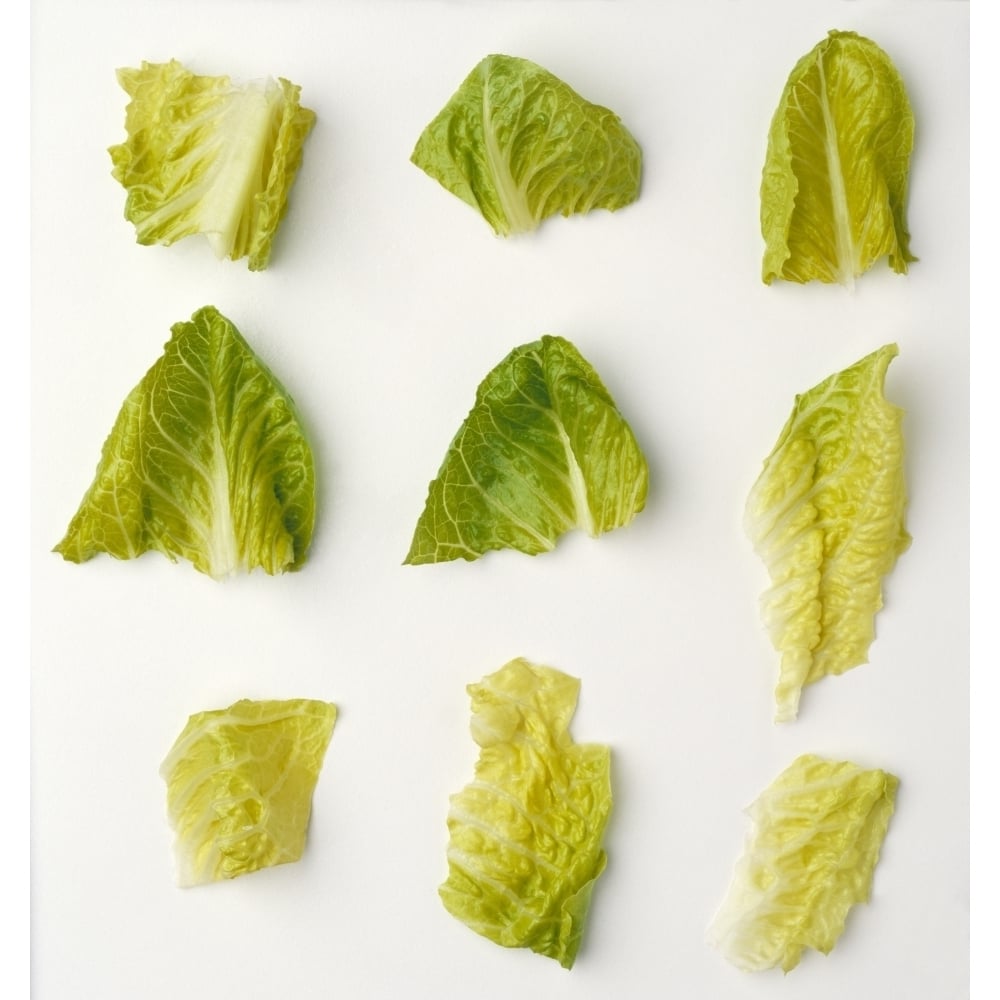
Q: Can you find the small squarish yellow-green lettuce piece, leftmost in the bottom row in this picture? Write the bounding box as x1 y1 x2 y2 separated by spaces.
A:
160 698 337 886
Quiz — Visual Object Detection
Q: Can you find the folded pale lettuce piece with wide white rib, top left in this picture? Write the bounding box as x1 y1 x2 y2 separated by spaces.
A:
108 60 316 271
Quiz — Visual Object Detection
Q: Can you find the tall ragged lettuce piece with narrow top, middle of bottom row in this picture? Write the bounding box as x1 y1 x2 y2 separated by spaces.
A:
438 659 611 969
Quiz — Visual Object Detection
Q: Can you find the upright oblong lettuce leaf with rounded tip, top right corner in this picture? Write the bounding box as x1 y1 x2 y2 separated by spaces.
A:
760 31 916 286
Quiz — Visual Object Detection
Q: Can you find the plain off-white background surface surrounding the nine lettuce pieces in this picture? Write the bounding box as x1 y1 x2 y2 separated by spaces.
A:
30 0 969 1000
